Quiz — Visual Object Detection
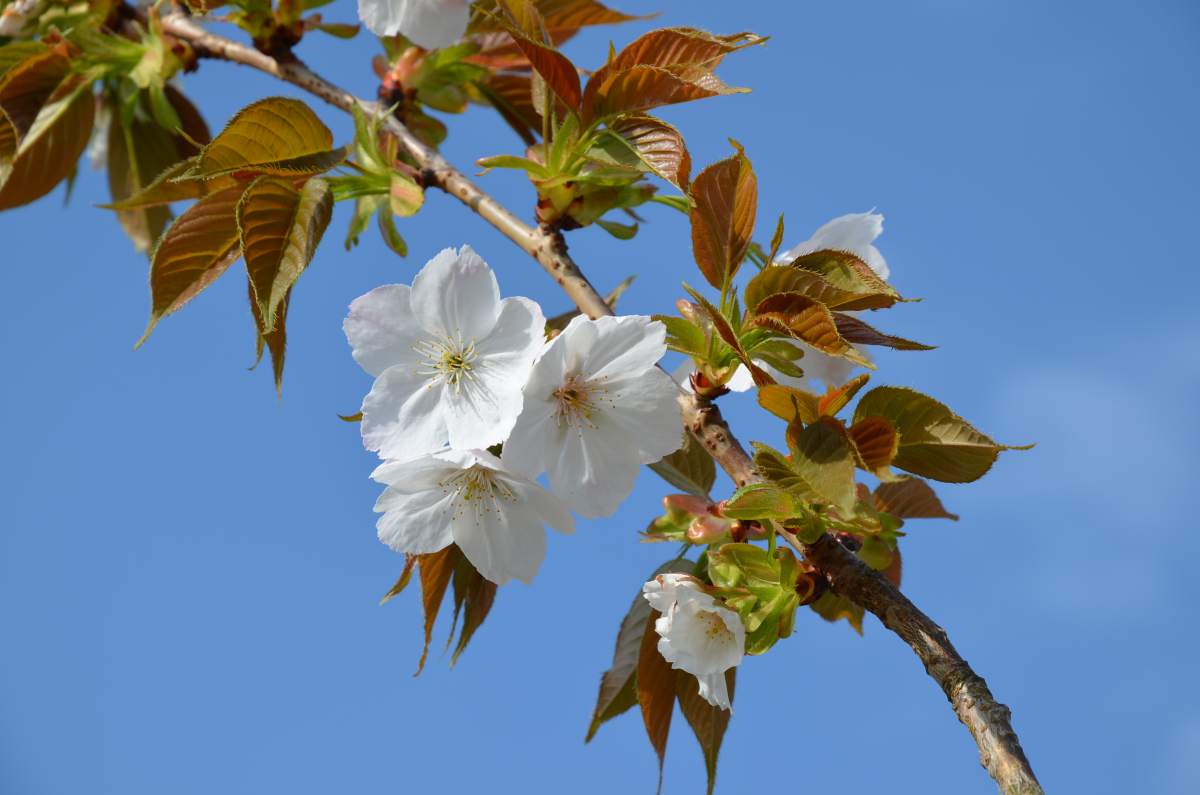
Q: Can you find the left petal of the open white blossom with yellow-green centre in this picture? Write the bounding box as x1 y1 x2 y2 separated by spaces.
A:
342 285 422 376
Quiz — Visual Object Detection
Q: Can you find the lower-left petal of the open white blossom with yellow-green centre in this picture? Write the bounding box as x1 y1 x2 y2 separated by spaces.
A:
361 367 448 460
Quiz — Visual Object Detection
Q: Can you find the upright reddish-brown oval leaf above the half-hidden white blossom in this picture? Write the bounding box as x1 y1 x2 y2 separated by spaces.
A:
691 148 758 289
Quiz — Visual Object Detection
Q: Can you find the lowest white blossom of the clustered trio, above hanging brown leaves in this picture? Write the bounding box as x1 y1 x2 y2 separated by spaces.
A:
371 450 575 585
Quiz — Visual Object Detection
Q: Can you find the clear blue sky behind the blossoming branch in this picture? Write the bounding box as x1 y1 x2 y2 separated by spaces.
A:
0 0 1200 795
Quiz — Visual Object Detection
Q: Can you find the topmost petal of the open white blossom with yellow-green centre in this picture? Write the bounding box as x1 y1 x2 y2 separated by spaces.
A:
412 246 500 341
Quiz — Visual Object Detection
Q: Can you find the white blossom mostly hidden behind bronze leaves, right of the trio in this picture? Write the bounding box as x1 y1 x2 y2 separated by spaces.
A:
725 213 892 391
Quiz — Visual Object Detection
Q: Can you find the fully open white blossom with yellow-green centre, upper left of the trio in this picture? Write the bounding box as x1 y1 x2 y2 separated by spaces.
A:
343 246 545 460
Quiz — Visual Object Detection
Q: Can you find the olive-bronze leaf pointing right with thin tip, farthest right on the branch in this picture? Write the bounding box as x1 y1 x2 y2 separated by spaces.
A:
854 387 1032 483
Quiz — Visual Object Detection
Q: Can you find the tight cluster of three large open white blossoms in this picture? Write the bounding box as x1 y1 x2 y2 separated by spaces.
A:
344 246 683 585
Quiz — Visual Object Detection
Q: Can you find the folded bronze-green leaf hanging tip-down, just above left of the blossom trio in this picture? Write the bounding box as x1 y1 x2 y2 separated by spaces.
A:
236 177 334 331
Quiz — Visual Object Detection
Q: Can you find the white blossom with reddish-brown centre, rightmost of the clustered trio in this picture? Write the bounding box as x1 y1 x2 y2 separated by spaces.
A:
504 315 683 518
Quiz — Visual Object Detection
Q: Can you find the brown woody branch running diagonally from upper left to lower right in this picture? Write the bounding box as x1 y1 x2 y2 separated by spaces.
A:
162 14 1042 795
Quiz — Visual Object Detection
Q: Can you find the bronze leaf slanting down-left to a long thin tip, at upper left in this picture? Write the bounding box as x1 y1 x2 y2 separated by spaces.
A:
134 186 242 347
